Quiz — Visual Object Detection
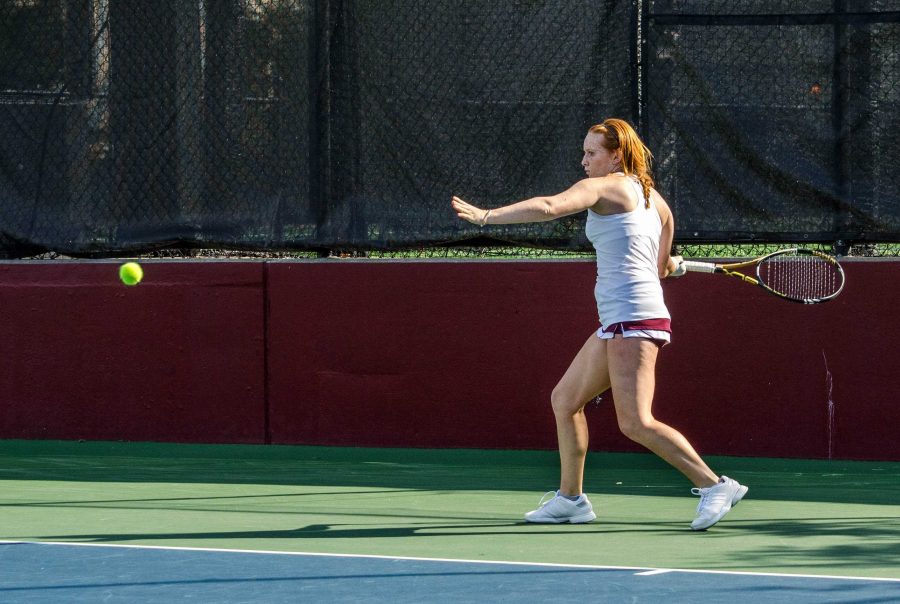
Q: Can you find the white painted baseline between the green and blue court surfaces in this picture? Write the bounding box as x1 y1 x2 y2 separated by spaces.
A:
0 539 900 583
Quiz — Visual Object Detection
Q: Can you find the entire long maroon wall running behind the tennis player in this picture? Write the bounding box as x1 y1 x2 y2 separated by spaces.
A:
0 260 900 460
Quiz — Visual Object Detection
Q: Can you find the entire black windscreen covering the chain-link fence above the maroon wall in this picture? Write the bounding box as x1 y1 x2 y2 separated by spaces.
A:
0 0 900 257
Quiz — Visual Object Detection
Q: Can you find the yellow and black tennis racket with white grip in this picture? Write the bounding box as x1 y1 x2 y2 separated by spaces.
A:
683 248 844 304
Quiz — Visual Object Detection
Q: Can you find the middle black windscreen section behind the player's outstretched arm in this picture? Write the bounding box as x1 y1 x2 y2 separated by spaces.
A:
322 0 633 246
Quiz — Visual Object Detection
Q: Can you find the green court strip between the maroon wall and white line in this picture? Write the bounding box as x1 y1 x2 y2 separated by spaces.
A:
0 441 900 578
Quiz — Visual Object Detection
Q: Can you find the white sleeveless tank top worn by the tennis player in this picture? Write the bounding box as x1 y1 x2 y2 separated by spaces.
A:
585 177 671 326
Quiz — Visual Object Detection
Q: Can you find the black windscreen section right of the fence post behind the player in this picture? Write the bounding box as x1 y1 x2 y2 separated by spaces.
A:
643 0 900 241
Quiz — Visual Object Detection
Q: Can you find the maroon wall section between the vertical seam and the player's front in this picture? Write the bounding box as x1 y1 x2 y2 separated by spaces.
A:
269 262 595 448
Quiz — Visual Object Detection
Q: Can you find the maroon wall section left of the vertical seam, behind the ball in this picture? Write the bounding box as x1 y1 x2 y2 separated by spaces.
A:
0 261 265 443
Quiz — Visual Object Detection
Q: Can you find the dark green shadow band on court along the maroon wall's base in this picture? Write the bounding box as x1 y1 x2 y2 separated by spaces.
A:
0 441 900 505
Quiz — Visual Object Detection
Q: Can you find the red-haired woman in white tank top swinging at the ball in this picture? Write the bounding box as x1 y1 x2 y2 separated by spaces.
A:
452 119 748 530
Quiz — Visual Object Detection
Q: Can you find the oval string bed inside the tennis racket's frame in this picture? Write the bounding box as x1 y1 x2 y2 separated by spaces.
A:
758 254 843 300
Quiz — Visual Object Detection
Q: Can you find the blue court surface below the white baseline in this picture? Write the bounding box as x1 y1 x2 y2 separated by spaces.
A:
0 543 900 603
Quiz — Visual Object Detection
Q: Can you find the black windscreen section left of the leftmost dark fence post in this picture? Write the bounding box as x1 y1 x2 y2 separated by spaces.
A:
0 0 315 251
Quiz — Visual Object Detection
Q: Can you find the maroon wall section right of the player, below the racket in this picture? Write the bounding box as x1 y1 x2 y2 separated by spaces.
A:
659 261 900 460
